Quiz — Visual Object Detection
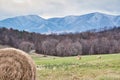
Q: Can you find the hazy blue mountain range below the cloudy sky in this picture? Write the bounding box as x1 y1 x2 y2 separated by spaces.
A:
0 12 120 33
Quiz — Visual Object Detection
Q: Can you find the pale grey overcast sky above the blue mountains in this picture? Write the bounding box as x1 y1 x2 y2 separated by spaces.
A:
0 0 120 19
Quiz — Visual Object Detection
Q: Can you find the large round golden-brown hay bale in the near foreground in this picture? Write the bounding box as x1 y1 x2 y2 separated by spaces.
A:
0 48 36 80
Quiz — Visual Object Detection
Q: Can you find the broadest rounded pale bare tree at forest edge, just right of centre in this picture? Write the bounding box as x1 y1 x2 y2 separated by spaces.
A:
56 39 82 56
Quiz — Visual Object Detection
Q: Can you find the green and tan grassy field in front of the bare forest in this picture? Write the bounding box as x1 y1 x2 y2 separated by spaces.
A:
31 54 120 80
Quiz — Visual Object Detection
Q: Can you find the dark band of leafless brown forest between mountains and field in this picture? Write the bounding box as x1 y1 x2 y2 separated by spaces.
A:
0 27 120 56
